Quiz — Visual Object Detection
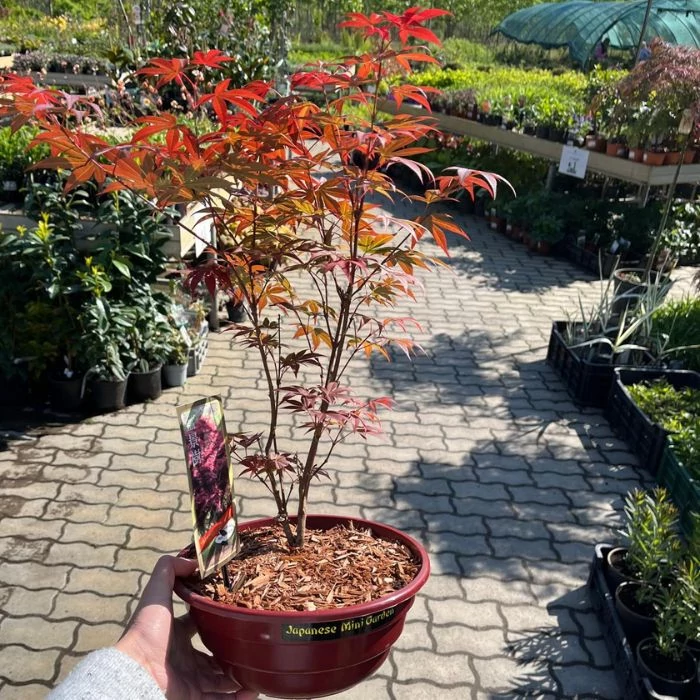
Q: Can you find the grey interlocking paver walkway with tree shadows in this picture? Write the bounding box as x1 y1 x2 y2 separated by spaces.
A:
0 198 700 700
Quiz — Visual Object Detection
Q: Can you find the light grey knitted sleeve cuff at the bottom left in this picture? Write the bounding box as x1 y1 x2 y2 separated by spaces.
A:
46 647 165 700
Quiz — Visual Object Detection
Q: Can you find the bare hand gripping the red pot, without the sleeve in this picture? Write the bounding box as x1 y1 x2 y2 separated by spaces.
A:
116 556 257 700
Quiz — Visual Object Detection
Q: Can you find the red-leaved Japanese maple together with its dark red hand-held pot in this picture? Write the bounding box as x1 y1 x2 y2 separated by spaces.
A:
0 8 516 697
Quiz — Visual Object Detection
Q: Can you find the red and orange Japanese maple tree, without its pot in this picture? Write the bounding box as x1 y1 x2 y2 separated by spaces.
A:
1 8 508 547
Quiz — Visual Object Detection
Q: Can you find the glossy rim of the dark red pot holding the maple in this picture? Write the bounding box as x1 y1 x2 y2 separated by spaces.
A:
174 513 430 622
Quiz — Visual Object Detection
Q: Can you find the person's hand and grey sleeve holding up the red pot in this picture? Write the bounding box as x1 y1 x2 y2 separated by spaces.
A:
47 556 257 700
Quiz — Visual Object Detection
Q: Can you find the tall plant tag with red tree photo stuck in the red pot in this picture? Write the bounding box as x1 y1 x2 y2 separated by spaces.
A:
177 396 240 578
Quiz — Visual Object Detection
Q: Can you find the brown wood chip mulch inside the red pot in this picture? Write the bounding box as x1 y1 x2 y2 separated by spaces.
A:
183 525 420 610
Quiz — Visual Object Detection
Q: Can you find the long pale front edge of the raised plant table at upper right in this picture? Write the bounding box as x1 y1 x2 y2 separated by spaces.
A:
378 100 700 187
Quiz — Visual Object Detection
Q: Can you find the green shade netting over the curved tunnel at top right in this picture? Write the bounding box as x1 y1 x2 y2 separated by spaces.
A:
493 0 700 65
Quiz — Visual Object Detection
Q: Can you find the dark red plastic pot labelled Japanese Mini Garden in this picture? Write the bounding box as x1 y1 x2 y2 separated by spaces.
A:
175 515 430 698
